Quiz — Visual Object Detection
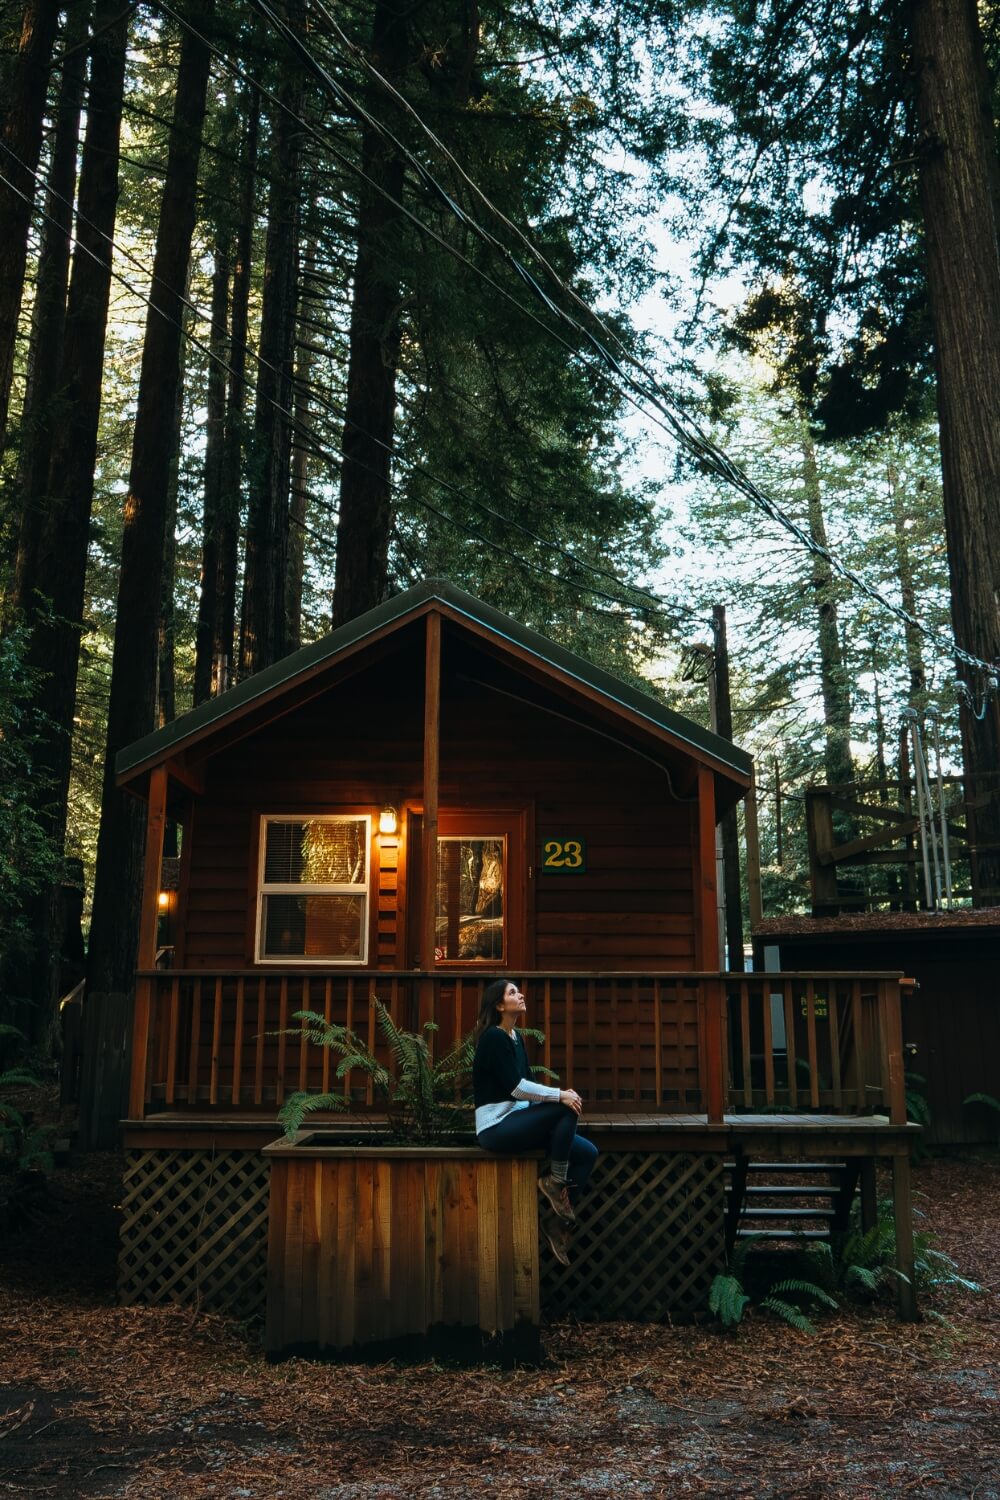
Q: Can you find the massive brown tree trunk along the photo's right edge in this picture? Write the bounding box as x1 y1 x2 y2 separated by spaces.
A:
910 0 1000 905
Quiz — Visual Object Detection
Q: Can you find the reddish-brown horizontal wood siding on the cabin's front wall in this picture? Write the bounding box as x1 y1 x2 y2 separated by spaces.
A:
178 632 702 972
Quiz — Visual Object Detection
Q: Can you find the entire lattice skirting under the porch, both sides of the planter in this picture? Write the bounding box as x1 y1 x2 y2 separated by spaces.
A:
118 1151 724 1323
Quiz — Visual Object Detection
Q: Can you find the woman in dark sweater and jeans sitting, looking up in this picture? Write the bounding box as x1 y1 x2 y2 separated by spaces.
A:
472 980 597 1266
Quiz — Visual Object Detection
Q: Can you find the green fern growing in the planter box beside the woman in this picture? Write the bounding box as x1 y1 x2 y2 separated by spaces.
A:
277 995 474 1145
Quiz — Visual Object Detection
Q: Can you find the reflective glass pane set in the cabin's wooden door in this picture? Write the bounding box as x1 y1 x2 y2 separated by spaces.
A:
435 836 505 963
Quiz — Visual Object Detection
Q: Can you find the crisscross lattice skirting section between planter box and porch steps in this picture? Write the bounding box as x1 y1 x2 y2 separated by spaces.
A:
541 1151 726 1323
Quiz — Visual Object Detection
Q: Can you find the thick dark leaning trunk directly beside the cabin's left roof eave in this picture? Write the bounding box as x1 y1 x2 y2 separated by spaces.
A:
81 0 211 1146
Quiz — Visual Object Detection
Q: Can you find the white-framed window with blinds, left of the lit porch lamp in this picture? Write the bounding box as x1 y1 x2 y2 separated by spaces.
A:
256 816 370 963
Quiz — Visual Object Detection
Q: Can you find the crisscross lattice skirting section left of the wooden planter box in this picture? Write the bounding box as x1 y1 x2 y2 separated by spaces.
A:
118 1151 268 1317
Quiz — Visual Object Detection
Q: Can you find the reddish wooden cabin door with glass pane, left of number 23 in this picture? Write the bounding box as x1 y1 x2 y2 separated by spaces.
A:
406 807 531 974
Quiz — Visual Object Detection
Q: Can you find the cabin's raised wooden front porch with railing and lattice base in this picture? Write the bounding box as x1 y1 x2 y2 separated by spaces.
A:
120 969 916 1320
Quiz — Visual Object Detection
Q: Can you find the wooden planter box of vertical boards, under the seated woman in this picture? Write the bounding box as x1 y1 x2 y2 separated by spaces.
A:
257 1130 540 1362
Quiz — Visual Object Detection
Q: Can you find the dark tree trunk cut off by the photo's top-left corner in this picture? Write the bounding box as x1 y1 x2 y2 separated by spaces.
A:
0 0 58 434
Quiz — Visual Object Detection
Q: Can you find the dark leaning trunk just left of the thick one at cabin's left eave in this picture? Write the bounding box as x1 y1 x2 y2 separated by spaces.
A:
6 0 127 1056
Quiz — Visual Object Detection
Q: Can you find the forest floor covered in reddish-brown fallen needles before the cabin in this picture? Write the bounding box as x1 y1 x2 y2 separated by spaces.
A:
0 1154 1000 1500
